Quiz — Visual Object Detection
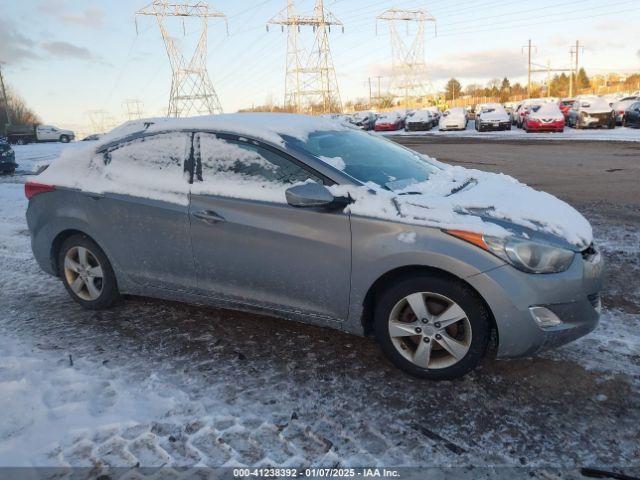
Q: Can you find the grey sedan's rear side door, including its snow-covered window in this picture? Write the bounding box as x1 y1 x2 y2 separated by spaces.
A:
85 132 195 290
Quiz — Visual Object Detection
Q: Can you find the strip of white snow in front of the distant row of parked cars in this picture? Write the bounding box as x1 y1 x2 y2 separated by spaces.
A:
378 120 640 142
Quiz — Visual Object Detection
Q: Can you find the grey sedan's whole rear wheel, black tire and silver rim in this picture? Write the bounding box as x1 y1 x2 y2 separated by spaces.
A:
58 235 120 310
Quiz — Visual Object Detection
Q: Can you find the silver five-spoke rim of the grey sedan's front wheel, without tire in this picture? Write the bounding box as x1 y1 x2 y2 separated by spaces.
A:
389 292 471 369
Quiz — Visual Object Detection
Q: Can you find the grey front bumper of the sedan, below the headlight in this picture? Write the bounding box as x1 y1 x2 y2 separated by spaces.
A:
467 249 604 357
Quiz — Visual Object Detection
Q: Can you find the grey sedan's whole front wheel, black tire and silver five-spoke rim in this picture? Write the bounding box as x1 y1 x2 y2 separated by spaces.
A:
374 276 490 380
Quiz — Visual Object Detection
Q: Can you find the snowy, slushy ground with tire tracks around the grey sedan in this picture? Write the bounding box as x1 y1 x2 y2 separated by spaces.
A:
0 142 640 478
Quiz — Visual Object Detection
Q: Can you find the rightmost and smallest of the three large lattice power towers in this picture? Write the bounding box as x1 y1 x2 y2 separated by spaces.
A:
376 8 436 106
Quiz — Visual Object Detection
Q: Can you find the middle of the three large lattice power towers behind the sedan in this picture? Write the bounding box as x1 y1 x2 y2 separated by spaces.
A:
267 0 344 113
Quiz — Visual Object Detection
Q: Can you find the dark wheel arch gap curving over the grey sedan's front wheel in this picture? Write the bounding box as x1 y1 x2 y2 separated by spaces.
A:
361 265 499 346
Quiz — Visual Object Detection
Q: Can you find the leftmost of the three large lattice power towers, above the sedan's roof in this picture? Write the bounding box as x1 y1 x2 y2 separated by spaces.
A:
136 0 228 117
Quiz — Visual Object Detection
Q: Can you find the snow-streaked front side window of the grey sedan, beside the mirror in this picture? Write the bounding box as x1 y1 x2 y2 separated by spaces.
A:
192 133 322 203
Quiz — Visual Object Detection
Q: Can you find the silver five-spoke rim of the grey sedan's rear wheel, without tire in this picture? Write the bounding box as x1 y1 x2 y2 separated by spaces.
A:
64 247 104 301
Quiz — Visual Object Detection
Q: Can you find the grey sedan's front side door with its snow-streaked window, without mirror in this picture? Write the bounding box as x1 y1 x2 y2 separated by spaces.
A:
190 133 351 320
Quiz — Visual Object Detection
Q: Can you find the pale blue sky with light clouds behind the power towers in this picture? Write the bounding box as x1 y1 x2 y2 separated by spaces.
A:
0 0 640 133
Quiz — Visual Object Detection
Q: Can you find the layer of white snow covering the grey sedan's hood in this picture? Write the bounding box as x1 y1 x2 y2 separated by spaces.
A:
329 159 593 250
